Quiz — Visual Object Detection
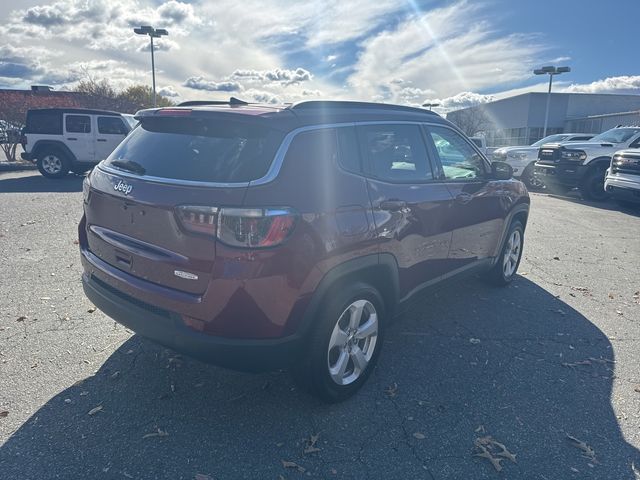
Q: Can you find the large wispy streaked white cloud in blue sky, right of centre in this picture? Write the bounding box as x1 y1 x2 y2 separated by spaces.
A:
348 1 541 101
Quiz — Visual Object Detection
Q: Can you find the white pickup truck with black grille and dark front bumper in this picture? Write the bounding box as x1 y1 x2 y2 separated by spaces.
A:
535 127 640 201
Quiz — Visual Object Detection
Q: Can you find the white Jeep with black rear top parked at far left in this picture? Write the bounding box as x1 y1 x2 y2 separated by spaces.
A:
22 108 132 178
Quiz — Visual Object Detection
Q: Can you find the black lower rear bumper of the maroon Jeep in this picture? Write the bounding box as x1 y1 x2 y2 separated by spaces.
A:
82 273 302 372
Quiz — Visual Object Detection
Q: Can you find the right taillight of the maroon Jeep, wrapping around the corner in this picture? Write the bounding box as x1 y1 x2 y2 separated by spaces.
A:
176 205 297 248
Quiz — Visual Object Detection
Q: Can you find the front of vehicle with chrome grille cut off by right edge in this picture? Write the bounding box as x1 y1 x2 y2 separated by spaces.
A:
604 149 640 206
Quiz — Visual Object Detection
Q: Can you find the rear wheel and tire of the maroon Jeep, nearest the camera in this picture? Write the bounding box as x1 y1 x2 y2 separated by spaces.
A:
292 282 386 403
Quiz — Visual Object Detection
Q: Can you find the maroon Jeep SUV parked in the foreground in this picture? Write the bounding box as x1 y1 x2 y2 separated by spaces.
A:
79 99 529 401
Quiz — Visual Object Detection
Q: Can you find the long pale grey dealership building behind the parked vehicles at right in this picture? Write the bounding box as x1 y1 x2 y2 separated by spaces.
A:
447 92 640 147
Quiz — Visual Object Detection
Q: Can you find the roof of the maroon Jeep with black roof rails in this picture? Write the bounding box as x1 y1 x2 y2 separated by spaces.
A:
136 99 449 130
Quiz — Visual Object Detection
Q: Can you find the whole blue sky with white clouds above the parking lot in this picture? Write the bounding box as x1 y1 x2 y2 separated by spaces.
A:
0 0 640 109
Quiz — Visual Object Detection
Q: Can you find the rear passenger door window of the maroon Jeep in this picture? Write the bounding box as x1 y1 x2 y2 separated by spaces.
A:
358 124 433 183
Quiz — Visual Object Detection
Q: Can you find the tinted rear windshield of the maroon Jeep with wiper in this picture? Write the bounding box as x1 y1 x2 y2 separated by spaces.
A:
105 118 284 183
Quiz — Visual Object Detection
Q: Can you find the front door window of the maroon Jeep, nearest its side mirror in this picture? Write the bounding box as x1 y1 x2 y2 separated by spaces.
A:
429 126 486 180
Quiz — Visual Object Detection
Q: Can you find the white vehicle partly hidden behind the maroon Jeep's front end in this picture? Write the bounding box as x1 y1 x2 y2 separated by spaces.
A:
493 133 594 188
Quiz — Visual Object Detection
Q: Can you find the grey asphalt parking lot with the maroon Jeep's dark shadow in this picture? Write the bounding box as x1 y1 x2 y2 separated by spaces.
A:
0 172 640 480
